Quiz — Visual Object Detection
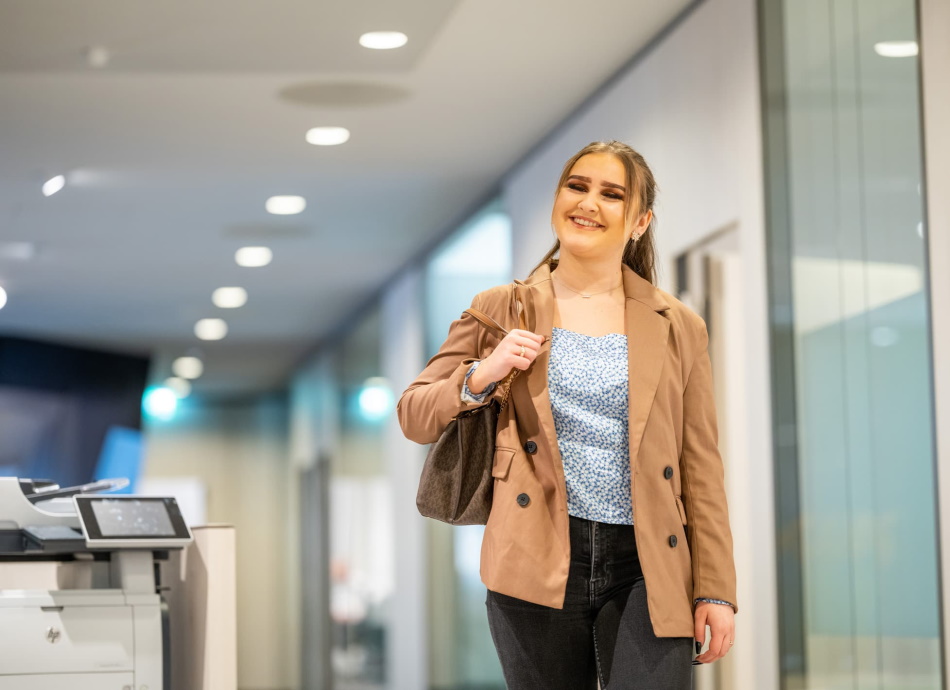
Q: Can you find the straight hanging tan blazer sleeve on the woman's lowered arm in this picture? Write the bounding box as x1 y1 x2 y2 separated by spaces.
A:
680 322 739 612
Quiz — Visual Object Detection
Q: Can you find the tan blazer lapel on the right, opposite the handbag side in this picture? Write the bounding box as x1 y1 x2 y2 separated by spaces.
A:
623 266 670 471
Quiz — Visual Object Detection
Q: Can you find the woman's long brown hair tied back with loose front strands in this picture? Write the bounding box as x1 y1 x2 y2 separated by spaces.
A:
531 141 656 285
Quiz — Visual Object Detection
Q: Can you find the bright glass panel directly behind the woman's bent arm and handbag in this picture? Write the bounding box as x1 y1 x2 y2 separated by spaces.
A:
425 204 511 690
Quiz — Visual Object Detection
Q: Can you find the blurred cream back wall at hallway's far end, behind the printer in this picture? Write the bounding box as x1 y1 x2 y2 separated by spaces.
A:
144 397 300 690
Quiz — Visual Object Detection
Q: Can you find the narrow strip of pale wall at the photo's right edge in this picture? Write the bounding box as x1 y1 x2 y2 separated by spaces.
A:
919 0 950 682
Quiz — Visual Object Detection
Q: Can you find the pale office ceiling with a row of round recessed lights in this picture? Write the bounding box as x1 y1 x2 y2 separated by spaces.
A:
0 0 690 397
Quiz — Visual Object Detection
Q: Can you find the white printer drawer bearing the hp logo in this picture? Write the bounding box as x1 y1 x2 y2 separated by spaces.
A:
0 606 135 672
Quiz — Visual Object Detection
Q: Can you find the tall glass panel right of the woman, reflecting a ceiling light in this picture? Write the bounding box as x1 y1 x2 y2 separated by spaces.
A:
760 0 942 690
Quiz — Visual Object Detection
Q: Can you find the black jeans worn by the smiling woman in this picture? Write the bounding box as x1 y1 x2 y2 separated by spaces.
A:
485 517 693 690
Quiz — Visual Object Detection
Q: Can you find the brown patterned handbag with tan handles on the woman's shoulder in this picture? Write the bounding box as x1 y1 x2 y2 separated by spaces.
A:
416 296 521 525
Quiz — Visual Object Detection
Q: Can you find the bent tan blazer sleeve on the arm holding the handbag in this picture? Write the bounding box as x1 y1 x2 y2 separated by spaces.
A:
396 288 497 443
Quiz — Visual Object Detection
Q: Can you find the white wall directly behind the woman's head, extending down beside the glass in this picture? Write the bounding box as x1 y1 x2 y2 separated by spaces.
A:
503 0 778 689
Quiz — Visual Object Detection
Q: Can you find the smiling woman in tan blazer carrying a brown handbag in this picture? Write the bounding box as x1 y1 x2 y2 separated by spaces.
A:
398 142 737 690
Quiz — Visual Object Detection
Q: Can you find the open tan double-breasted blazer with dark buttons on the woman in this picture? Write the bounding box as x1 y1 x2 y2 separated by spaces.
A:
397 266 737 637
